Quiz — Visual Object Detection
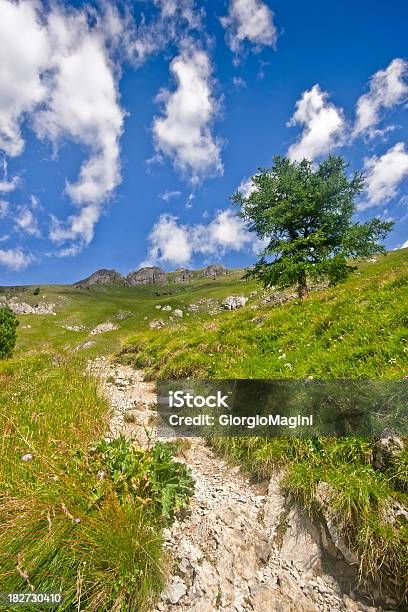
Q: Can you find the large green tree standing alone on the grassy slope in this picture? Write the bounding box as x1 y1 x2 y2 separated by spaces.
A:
232 156 393 298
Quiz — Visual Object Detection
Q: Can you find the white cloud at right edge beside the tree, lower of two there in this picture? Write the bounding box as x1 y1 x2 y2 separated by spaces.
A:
359 142 408 210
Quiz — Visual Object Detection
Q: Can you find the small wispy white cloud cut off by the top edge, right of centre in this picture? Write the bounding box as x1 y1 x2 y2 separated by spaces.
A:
221 0 278 53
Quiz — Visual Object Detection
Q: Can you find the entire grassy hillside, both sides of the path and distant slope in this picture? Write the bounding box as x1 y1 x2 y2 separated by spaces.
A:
0 250 408 610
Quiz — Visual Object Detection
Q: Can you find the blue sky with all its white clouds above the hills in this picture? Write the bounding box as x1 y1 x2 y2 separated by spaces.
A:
0 0 408 284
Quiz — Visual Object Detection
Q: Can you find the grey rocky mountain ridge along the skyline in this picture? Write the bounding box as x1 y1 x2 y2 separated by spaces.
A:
74 264 229 288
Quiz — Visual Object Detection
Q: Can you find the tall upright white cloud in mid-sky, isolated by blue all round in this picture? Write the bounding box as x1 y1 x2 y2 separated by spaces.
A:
153 41 223 183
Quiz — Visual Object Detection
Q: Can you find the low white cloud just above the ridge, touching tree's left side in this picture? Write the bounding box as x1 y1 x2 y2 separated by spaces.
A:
143 208 253 266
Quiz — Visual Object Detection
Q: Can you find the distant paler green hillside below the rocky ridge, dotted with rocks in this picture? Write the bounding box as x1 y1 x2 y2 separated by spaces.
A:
0 271 256 356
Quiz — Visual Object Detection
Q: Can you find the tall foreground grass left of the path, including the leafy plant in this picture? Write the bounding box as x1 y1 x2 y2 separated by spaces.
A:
0 353 192 611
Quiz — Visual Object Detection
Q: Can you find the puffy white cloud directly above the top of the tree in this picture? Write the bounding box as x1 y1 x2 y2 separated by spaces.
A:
288 85 346 161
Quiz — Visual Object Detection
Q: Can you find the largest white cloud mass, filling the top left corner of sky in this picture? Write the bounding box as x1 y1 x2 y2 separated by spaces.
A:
0 0 124 253
